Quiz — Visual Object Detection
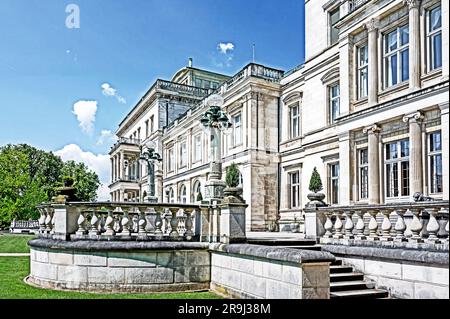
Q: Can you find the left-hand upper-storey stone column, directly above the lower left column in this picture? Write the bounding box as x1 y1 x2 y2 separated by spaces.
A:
365 19 379 106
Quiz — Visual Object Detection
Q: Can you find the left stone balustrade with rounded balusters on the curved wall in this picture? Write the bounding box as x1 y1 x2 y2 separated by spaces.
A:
38 202 206 241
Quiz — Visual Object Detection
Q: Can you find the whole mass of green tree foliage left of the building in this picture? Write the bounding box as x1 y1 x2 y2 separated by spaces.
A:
0 144 100 228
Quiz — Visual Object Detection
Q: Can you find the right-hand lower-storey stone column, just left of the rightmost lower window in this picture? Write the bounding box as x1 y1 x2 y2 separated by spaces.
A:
403 112 423 201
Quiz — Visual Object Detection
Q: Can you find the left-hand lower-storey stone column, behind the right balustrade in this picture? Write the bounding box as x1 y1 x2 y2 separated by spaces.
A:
363 124 381 205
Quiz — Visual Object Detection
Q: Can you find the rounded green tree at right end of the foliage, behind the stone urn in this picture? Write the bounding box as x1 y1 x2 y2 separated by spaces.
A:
61 161 100 201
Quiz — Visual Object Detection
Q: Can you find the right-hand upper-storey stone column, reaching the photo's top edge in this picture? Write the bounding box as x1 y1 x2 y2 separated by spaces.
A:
404 0 422 90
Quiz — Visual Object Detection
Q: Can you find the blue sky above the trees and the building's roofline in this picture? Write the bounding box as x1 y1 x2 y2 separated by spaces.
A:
0 0 304 198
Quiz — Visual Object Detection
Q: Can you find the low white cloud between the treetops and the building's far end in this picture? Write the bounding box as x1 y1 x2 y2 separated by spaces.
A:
55 144 111 201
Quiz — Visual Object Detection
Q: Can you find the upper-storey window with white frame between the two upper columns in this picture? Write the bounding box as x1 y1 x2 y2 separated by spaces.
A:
384 25 409 88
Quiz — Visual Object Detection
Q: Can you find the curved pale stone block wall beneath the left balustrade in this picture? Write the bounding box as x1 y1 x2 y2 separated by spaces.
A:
26 239 211 293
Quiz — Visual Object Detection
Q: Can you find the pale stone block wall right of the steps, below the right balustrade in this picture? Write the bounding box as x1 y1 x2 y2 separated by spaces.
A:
323 243 449 299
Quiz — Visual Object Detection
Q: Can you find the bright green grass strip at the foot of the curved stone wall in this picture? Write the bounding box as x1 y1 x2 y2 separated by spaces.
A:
0 257 221 299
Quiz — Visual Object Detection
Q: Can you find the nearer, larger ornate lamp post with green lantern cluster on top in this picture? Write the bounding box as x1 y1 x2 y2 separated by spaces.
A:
200 94 232 201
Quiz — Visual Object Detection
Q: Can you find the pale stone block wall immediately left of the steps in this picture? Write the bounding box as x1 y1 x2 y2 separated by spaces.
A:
211 244 334 299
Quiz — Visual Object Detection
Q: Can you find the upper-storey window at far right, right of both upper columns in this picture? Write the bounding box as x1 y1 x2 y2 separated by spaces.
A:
427 6 442 71
